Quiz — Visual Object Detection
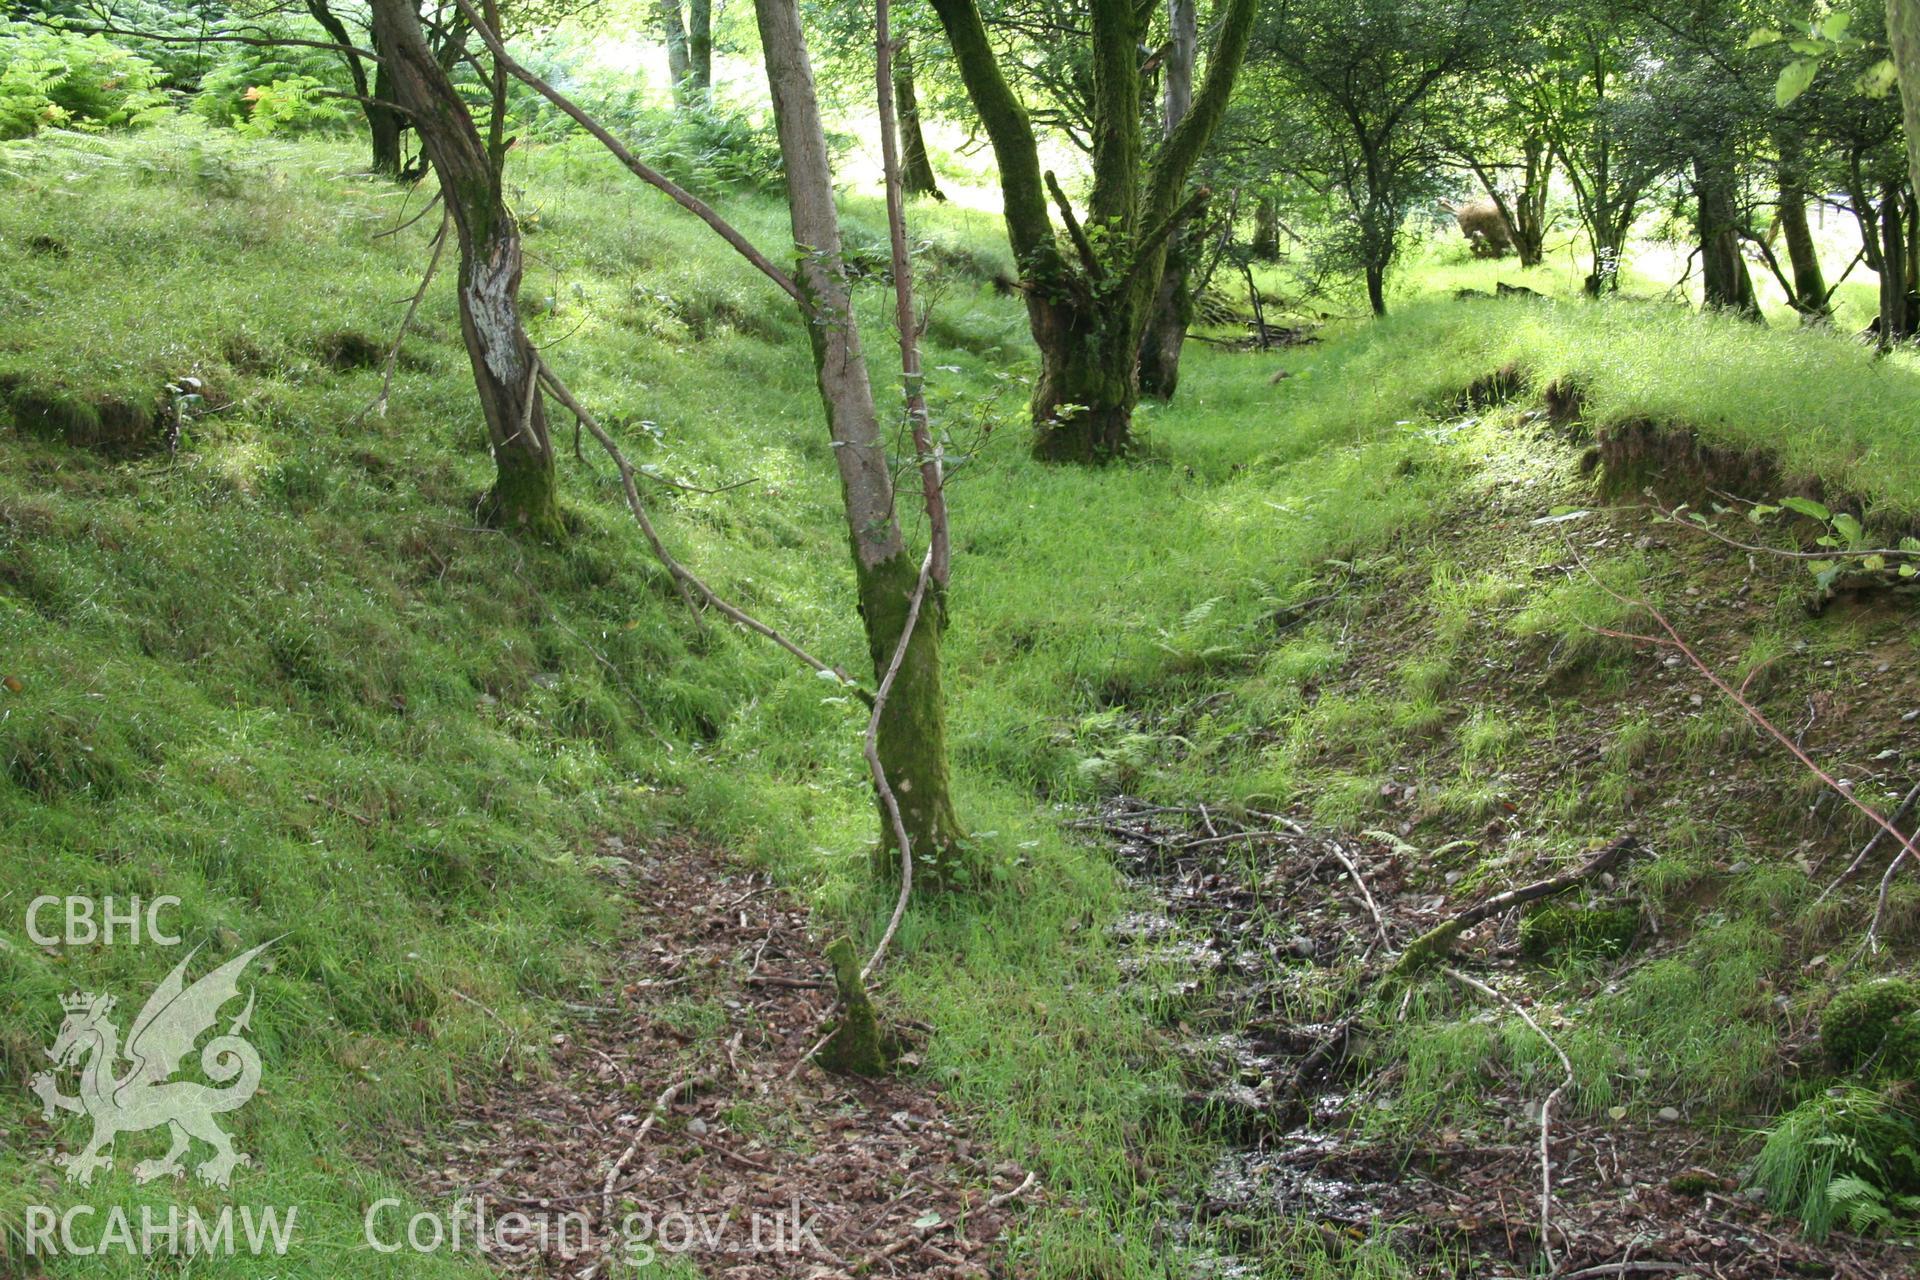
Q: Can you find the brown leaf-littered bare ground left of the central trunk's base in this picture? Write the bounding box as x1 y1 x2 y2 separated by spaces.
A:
401 839 1023 1280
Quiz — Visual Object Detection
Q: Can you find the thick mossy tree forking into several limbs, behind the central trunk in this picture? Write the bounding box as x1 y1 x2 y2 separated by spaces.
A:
933 0 1256 462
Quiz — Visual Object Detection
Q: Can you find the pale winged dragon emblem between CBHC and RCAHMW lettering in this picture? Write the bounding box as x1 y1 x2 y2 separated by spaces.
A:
31 942 273 1186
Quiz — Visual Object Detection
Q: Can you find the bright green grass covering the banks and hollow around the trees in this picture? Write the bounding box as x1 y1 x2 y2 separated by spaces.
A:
11 115 1920 1278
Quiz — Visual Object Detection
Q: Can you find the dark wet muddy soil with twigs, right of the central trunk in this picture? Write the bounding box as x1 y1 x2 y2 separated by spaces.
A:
1081 796 1914 1280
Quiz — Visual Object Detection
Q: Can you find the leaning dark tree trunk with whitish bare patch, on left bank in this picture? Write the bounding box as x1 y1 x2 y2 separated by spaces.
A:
372 0 566 541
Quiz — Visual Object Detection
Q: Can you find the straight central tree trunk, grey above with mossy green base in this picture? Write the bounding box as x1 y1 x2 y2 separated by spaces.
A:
753 0 975 887
